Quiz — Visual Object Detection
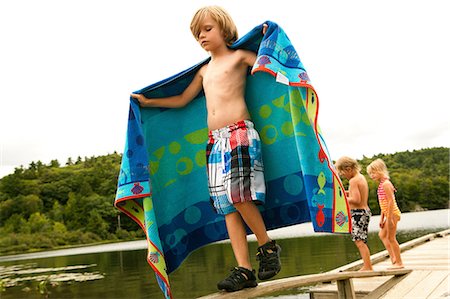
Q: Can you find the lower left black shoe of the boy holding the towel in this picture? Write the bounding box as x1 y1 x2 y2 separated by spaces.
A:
217 267 258 292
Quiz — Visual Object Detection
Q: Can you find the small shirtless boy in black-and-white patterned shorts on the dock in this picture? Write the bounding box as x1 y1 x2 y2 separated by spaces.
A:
336 157 373 271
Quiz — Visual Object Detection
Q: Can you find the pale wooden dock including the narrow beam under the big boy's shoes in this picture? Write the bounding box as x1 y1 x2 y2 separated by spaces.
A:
201 229 450 299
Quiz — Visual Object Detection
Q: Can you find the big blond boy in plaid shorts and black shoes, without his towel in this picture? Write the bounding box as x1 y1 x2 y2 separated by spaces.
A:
131 6 281 291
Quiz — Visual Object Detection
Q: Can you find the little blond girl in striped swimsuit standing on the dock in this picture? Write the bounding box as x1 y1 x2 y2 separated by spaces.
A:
367 159 404 269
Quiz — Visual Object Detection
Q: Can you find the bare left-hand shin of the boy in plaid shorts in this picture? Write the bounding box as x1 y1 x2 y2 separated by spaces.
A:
225 212 253 270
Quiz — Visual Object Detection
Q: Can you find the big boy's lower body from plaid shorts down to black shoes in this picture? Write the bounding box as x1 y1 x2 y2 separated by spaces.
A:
206 119 281 291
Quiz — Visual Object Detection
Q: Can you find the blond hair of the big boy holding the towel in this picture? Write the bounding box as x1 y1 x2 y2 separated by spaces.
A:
191 5 238 45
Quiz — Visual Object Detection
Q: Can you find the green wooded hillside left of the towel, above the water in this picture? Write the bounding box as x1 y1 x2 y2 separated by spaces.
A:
0 153 143 254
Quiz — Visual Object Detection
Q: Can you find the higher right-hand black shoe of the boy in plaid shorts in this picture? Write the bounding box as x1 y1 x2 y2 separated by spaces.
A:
256 240 281 280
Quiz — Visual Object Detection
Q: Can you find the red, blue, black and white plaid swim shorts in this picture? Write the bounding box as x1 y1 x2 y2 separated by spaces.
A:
206 120 266 215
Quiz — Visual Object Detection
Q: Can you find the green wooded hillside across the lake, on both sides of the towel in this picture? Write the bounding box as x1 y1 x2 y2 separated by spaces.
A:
0 147 449 255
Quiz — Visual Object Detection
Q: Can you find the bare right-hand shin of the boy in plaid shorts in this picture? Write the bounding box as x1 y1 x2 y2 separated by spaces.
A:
234 202 270 246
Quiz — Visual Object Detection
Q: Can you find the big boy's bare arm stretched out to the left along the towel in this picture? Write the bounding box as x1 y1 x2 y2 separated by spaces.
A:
131 65 206 108
